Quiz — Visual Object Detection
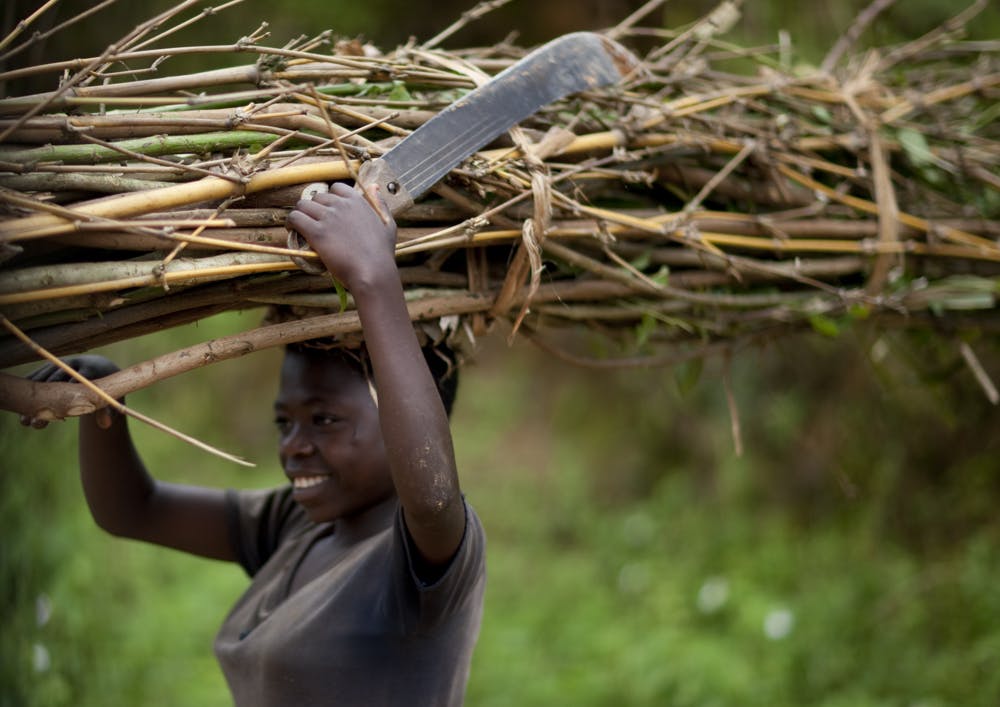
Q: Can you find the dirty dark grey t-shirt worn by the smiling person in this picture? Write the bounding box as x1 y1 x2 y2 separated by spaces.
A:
215 487 486 707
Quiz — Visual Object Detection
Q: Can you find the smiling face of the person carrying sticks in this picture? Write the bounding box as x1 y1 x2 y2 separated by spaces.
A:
274 351 395 522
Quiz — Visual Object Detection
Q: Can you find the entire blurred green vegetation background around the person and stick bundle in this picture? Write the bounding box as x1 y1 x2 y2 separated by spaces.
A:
0 0 1000 707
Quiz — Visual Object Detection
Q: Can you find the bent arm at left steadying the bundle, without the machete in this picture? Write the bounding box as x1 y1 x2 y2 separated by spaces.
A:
24 356 236 560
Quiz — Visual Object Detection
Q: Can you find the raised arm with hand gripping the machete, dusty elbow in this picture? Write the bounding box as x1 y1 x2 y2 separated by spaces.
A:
288 183 465 564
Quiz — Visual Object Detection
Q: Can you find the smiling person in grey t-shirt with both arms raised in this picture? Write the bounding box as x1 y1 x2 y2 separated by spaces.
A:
25 184 485 707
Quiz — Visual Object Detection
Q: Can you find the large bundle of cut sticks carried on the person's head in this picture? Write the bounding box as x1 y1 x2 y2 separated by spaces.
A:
0 0 1000 426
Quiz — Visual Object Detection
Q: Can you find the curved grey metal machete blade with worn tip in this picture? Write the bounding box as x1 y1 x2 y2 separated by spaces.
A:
359 32 639 214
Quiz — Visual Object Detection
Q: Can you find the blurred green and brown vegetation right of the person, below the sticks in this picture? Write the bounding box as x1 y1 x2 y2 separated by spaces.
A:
456 332 1000 706
